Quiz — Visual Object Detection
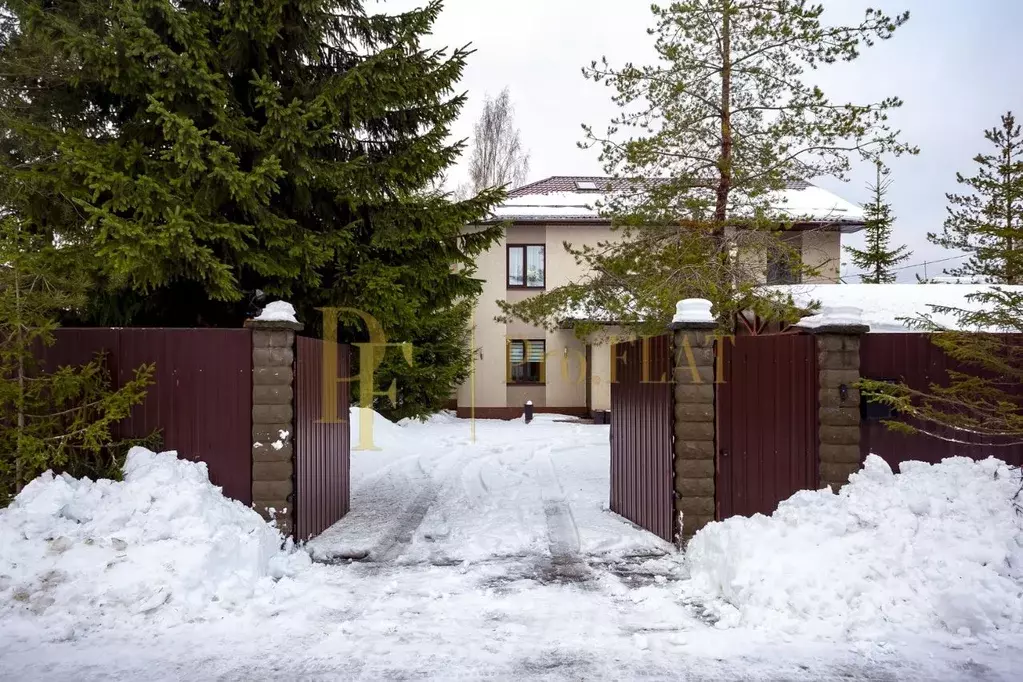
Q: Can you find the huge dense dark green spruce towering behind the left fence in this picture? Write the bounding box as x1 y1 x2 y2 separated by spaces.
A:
0 0 501 416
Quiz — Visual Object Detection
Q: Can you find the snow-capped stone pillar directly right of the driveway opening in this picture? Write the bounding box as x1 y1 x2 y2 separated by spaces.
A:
670 299 717 542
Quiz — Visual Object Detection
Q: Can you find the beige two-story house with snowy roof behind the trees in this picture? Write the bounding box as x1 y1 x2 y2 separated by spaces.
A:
457 176 863 418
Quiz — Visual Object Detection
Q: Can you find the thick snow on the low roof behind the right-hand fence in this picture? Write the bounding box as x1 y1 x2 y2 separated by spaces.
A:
765 284 1023 333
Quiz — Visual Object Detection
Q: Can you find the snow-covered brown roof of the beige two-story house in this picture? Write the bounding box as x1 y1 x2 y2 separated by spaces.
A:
494 176 863 232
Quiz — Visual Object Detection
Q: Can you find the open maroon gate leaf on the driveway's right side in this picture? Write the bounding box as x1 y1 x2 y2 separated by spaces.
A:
611 335 675 542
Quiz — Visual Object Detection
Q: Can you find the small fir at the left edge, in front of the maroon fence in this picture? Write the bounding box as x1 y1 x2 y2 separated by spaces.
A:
0 216 152 503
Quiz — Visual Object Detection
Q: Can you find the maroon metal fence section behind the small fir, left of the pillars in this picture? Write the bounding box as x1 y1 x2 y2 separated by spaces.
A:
39 328 252 504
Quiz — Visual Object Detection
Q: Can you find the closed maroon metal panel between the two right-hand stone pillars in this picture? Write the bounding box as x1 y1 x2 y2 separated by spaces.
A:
715 334 818 518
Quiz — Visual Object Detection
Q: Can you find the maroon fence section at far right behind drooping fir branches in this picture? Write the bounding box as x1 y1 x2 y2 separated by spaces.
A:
859 333 1023 470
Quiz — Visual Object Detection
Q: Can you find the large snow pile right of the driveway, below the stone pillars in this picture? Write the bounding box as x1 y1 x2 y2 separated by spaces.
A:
683 456 1023 639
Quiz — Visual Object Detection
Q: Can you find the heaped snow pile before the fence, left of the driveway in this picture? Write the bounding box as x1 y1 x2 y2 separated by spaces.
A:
0 448 309 629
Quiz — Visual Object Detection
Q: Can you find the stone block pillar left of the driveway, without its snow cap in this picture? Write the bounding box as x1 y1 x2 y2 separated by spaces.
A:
246 310 303 535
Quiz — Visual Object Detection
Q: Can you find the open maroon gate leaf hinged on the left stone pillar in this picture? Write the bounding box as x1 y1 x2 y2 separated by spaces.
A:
295 336 351 540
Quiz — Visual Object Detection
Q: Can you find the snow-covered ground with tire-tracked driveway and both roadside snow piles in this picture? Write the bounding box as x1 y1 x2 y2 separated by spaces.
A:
0 415 1023 680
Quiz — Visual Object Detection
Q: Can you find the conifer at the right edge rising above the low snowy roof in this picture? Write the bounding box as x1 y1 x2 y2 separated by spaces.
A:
927 111 1023 284
